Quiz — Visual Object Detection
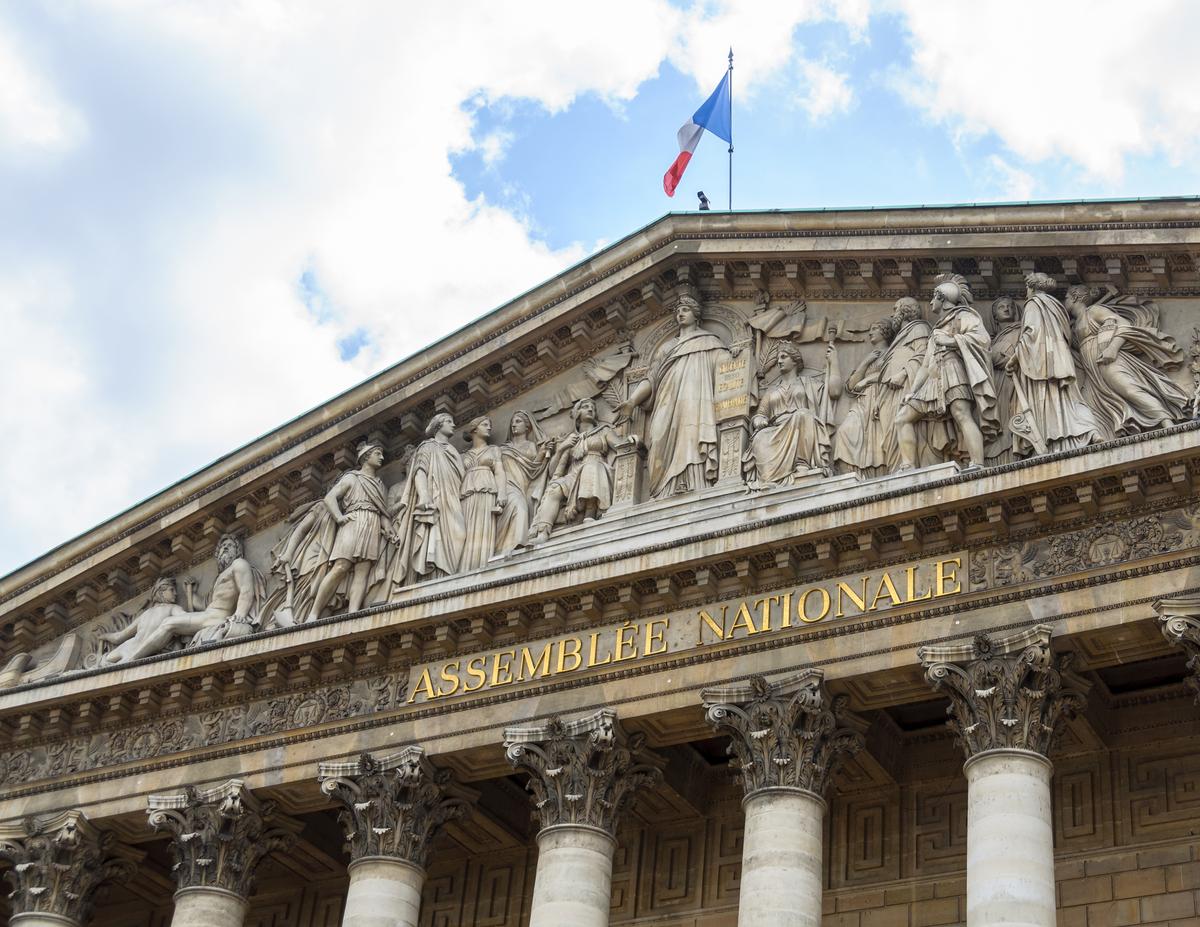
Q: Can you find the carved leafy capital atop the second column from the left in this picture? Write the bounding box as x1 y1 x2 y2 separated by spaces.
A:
146 779 299 898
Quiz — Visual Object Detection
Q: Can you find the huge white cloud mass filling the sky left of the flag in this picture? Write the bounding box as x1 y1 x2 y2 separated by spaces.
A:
0 0 857 573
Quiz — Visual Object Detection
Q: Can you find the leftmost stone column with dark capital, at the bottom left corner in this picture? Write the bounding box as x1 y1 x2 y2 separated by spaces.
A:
0 811 142 927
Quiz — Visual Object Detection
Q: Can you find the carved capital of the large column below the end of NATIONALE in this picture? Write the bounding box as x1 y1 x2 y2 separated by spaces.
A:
917 624 1091 759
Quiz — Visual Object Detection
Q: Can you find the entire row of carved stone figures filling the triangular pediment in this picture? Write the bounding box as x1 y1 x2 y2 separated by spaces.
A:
14 273 1193 677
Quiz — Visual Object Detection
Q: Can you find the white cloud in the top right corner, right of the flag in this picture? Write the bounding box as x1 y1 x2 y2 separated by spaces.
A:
888 0 1200 181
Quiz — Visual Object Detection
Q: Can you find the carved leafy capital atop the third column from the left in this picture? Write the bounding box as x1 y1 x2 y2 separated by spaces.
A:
317 747 475 869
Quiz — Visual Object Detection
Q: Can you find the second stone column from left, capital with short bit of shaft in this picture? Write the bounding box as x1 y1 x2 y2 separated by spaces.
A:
146 779 299 927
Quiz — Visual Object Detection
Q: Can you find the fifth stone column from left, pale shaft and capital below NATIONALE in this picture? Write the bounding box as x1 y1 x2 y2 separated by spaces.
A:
701 669 863 927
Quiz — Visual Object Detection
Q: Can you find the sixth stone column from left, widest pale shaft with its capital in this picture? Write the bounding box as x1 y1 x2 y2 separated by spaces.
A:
917 624 1087 927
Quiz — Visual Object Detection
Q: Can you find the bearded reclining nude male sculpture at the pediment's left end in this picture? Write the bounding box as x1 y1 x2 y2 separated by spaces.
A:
98 534 265 664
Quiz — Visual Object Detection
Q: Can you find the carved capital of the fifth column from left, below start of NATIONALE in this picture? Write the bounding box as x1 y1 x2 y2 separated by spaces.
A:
700 669 864 797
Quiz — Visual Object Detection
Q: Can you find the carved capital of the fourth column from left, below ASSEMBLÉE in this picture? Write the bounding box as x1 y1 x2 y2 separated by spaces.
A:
504 708 662 837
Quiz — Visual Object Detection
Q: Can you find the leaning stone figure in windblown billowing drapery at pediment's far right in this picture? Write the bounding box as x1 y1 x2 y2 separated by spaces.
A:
1067 286 1189 437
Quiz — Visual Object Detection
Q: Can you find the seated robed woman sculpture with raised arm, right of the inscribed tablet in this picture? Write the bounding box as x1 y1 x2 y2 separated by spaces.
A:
742 342 842 489
